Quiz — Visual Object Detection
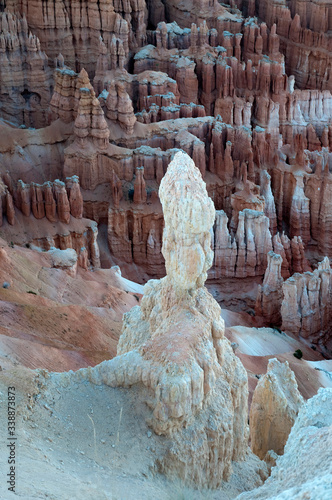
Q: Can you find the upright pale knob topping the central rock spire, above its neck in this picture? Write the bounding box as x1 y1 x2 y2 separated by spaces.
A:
159 153 215 293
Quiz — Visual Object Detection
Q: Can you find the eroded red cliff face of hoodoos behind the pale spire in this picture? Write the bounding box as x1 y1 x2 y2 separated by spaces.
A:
0 0 332 356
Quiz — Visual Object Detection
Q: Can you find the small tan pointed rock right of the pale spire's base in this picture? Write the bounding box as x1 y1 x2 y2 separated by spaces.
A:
249 358 303 459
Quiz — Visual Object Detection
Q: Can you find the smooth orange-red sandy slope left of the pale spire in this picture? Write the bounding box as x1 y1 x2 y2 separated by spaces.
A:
0 240 142 371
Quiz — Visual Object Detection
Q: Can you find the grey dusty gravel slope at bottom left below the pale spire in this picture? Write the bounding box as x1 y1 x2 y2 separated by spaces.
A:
0 361 259 500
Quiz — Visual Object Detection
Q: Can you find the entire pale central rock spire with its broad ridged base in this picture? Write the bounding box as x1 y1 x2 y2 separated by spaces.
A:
72 152 248 488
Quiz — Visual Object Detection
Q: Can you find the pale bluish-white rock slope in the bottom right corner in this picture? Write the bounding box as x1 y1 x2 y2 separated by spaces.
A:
237 388 332 500
